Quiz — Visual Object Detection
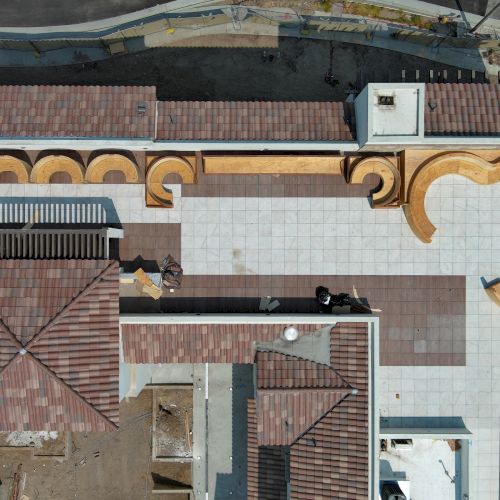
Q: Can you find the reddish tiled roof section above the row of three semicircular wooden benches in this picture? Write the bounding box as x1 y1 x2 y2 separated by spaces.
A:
0 85 156 138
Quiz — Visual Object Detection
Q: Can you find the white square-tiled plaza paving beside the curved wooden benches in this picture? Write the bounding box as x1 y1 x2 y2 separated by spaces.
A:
0 170 500 500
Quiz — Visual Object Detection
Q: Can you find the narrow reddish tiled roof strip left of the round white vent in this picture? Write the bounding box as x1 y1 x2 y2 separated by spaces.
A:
121 323 319 364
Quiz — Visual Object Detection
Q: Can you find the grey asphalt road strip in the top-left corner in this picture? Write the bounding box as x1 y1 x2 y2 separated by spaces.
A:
0 0 173 27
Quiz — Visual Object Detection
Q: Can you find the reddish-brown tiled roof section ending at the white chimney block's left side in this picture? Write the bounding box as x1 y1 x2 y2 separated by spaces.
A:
157 101 355 141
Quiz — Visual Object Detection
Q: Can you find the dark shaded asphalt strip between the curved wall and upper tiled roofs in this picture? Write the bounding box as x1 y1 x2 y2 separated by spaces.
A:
0 38 480 101
